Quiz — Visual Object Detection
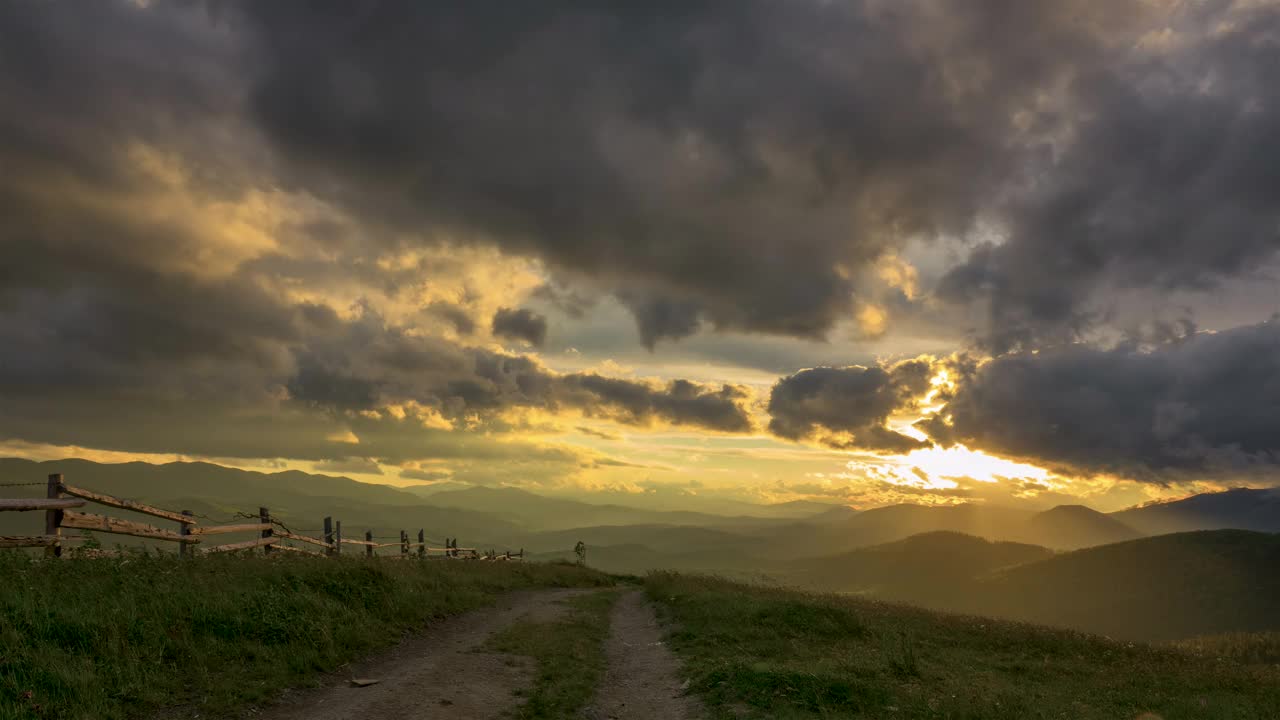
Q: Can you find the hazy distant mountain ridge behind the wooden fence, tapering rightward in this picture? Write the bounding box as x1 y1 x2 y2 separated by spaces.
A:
0 457 829 547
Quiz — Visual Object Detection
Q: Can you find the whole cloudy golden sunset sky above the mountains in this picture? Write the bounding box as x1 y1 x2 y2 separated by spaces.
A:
0 0 1280 510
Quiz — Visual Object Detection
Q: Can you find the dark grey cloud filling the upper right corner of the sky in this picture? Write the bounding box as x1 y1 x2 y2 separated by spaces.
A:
940 3 1280 352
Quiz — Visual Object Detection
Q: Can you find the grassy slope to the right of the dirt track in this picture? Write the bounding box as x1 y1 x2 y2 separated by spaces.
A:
645 573 1280 720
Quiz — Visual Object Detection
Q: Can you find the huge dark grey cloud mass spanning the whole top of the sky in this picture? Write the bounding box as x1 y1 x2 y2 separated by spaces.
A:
0 0 1280 350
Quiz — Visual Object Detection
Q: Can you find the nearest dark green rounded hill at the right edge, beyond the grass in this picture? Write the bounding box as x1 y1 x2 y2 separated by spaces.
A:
963 530 1280 639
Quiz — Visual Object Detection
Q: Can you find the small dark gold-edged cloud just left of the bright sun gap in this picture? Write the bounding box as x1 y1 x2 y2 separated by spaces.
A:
769 359 934 452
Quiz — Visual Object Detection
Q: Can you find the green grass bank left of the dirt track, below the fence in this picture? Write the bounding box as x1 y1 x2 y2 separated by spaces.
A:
0 552 612 720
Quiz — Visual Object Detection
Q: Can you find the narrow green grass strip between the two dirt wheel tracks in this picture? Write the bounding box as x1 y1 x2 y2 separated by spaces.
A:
486 591 618 720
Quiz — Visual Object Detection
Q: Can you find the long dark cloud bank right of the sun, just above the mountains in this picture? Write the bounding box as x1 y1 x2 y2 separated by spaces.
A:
927 320 1280 482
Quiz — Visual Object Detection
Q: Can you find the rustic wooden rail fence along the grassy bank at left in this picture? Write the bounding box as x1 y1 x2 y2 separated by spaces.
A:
0 474 525 561
